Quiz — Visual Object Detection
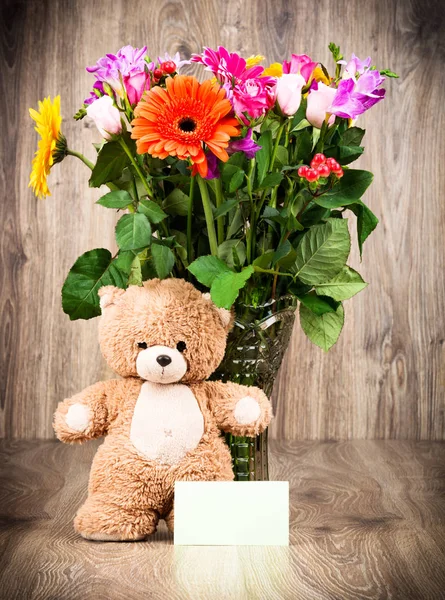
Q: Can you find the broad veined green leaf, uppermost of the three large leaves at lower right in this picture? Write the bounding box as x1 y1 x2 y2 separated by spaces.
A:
293 219 351 285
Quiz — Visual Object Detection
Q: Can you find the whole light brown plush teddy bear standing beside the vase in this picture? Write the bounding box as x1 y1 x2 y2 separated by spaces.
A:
54 278 272 541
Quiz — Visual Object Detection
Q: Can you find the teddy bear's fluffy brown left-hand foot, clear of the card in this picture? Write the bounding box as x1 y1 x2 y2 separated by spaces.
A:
74 494 159 542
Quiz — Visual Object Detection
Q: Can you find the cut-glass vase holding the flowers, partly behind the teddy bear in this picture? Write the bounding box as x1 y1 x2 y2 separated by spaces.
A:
212 295 297 481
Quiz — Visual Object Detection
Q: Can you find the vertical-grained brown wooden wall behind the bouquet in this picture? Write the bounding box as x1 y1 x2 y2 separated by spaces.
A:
0 0 445 440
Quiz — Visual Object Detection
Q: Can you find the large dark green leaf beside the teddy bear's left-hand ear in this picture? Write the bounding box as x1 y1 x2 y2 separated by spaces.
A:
62 248 127 321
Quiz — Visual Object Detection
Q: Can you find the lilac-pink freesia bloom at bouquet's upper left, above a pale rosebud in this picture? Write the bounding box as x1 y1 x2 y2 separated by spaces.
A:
87 46 150 104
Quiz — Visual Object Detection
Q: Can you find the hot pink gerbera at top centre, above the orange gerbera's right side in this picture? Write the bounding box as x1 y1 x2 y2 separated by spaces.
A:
191 46 264 84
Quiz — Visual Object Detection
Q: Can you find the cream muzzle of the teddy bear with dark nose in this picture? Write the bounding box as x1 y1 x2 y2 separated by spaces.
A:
136 346 187 383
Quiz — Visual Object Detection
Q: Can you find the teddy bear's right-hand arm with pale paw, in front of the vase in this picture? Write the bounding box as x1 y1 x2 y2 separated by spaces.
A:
201 381 272 437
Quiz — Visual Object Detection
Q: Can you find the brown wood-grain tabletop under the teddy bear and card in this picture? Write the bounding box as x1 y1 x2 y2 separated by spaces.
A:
0 441 445 600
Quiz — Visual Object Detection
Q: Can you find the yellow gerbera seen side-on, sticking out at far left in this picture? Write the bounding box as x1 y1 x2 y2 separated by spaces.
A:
28 96 66 198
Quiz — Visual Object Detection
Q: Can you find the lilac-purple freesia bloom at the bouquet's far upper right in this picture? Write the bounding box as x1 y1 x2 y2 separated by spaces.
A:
328 70 386 119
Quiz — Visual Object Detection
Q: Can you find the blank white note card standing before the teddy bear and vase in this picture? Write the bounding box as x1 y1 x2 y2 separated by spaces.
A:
174 481 289 546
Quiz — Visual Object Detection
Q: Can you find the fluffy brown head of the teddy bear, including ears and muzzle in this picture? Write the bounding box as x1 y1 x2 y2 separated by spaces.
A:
99 279 232 384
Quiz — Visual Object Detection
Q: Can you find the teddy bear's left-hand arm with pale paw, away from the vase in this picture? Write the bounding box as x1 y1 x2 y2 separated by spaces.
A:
54 379 119 443
